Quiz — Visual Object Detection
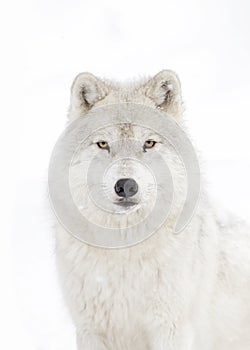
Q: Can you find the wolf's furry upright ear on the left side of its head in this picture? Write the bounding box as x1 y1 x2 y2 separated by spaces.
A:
69 73 108 119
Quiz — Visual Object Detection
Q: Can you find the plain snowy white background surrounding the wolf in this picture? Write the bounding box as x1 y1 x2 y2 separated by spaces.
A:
0 0 250 350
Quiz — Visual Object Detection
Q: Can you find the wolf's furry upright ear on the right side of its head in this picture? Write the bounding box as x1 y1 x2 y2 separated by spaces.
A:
144 70 183 117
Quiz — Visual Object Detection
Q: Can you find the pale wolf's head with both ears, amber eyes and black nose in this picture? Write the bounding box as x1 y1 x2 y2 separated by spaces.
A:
64 70 191 245
